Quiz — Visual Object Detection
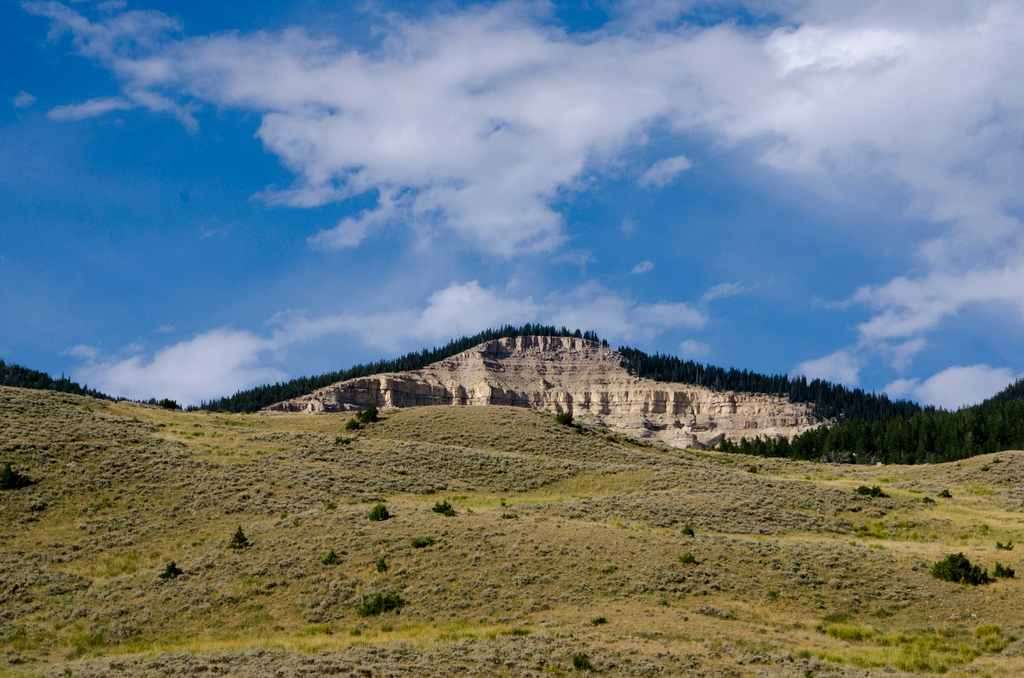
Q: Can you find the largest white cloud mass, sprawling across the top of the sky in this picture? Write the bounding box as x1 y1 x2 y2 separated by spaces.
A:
25 2 1024 266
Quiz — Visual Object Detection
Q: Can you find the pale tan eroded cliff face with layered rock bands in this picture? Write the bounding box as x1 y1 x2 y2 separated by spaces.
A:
267 337 816 447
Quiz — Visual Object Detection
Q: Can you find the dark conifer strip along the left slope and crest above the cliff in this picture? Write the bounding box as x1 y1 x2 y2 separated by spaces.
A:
190 323 607 412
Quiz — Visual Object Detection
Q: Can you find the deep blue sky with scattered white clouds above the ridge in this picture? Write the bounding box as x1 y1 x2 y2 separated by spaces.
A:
0 0 1024 407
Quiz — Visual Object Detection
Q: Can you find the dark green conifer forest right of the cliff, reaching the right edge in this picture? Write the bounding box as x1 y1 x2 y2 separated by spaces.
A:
722 380 1024 464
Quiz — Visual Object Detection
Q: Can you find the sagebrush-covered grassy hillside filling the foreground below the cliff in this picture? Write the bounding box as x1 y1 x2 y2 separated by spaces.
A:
0 388 1024 677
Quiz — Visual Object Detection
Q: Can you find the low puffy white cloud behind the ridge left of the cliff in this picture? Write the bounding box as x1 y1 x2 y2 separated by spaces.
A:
74 329 285 404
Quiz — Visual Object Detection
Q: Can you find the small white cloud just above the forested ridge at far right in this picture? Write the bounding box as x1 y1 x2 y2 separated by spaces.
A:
885 365 1022 410
